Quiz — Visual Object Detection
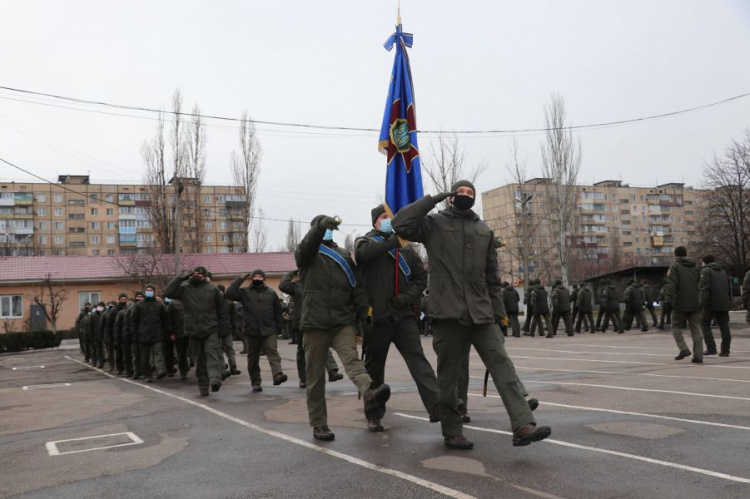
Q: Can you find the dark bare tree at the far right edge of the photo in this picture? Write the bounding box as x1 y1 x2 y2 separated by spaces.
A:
697 130 750 275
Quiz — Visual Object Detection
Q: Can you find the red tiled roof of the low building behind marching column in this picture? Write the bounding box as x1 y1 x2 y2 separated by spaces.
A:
0 252 297 285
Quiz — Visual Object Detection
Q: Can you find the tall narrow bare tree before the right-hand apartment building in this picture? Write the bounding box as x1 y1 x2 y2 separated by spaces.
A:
541 94 581 286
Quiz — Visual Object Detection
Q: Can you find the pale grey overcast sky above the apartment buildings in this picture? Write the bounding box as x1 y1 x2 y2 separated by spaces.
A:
0 0 750 248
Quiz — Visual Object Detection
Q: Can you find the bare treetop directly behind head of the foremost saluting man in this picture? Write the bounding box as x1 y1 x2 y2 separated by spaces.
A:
422 133 487 207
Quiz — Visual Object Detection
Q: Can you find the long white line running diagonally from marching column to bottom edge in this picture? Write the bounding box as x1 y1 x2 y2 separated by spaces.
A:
65 355 475 499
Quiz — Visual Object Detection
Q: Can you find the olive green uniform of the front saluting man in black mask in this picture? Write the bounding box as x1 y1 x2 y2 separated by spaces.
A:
392 196 535 439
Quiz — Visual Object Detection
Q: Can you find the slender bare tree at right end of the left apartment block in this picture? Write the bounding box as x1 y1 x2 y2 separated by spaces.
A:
230 111 265 252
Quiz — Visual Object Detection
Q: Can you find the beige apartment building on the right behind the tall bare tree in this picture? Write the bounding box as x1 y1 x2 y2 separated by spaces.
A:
482 178 706 283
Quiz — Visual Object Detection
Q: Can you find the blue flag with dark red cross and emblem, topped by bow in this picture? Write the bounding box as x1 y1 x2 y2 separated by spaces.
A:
378 24 424 214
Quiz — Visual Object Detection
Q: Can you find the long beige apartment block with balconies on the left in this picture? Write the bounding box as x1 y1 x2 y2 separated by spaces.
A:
0 175 253 256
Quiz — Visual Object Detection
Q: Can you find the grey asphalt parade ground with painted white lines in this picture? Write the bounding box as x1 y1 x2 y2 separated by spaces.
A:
0 328 750 499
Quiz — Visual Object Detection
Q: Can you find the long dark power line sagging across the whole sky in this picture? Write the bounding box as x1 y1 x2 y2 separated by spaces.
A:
0 86 750 135
